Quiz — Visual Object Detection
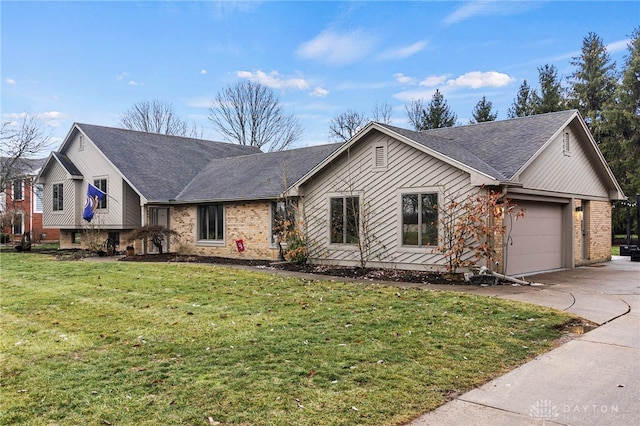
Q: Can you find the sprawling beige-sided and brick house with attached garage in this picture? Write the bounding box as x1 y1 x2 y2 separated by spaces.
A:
39 110 624 275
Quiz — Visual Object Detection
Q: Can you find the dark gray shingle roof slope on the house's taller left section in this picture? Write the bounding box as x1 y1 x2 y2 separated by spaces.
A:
76 123 261 201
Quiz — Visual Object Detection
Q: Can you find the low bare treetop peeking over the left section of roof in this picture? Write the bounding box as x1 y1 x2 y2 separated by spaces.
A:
120 99 201 137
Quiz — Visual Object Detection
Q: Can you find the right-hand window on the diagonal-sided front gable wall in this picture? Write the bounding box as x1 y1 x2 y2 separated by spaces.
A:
402 193 438 247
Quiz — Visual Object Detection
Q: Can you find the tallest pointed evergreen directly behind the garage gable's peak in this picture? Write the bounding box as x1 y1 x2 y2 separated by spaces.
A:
569 32 616 138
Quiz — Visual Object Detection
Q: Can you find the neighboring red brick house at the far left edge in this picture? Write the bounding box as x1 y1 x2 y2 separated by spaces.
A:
0 158 60 242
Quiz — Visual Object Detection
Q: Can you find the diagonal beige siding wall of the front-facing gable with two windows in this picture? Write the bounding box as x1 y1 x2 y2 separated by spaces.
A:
302 132 474 269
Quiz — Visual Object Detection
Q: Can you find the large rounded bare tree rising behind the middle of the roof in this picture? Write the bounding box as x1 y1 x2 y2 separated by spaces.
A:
209 81 302 151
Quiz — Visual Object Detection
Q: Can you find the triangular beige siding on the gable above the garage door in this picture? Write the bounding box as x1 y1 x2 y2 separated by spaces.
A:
517 127 609 199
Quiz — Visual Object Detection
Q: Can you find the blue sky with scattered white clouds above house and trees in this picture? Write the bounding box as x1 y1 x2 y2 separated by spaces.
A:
0 0 640 148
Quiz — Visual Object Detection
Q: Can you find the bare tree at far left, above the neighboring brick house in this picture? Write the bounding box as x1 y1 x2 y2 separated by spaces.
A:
0 114 51 192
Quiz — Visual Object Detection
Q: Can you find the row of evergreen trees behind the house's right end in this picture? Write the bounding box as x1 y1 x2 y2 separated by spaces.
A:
396 27 640 234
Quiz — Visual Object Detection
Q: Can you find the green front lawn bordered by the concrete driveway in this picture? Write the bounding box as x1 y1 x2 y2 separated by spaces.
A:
0 252 571 425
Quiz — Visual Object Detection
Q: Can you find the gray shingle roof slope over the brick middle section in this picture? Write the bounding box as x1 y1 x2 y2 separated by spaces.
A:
177 144 342 202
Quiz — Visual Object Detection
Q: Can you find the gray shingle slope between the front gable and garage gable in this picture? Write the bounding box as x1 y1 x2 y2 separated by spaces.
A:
420 110 576 180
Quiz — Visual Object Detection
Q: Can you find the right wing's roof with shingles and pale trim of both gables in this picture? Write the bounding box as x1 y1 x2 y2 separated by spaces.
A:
297 110 622 199
